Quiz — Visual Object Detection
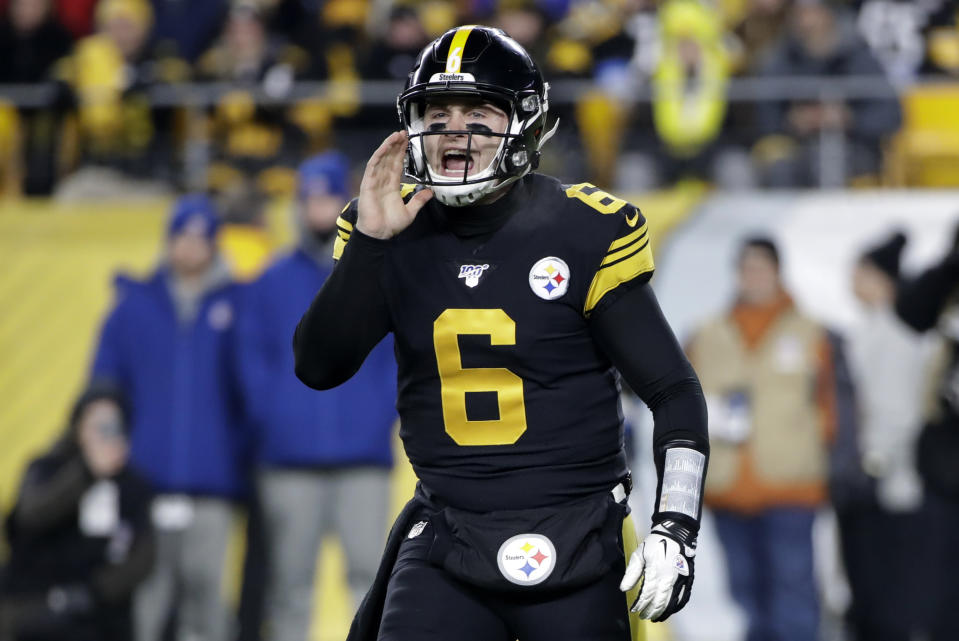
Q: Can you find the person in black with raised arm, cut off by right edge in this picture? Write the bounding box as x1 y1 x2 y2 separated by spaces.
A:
896 224 959 641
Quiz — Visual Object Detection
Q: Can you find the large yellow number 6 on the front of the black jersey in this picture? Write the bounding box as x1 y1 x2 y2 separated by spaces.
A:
433 309 526 445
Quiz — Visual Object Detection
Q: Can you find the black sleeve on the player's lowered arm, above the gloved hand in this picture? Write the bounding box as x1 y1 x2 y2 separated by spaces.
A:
590 284 709 530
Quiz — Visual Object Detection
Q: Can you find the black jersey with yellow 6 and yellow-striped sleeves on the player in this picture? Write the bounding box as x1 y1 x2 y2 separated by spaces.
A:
334 174 653 511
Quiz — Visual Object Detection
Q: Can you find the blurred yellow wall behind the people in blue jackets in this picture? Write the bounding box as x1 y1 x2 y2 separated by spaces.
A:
0 187 702 641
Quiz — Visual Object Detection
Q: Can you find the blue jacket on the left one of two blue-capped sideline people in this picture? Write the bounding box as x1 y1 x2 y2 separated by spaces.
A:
92 268 248 498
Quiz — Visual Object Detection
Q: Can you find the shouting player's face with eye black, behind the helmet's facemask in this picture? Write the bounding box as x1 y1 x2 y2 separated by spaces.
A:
423 98 509 178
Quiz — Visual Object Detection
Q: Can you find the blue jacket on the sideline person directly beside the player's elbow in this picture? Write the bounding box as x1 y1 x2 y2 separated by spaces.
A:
237 249 396 467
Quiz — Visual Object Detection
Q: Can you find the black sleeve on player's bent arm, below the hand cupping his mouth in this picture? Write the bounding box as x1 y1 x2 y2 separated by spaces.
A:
293 229 390 390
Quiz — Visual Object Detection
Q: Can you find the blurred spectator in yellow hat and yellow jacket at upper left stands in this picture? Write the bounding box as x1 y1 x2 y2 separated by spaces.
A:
58 0 189 200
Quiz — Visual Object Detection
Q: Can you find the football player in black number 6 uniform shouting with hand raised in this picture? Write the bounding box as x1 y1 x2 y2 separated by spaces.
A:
294 26 708 641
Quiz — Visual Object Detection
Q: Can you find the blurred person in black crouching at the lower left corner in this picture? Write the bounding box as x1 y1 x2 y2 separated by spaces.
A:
0 387 154 641
